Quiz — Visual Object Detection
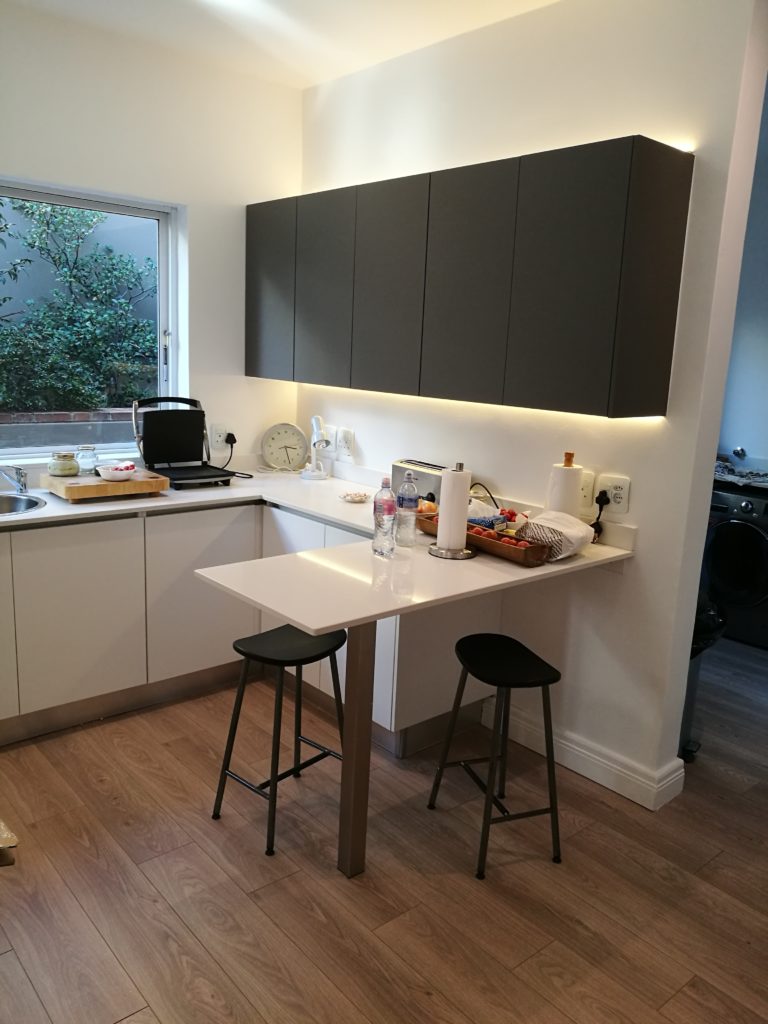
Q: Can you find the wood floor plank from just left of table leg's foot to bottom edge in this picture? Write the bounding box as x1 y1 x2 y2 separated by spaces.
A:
252 874 470 1024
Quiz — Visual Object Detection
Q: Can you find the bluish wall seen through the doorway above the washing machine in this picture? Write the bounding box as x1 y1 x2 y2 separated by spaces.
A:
719 75 768 472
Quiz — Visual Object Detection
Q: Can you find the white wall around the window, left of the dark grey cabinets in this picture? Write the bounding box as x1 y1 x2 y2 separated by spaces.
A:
0 0 301 458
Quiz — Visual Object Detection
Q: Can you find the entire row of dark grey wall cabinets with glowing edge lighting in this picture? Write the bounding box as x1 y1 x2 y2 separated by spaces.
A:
246 135 693 417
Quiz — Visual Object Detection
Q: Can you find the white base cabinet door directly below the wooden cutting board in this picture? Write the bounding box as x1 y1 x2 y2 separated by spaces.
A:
11 519 146 715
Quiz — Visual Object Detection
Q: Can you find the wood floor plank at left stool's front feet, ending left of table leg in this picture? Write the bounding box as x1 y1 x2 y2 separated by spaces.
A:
81 717 298 892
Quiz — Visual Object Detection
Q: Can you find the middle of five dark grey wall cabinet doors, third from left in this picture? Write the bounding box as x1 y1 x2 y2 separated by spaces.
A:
351 174 429 394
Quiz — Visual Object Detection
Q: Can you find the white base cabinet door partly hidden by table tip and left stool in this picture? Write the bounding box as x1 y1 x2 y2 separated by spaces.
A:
145 505 261 683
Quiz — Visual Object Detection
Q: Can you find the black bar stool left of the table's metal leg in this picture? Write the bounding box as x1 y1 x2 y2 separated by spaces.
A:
212 626 347 857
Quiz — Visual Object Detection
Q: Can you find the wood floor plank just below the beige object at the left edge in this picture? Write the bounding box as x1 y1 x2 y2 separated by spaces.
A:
0 811 146 1024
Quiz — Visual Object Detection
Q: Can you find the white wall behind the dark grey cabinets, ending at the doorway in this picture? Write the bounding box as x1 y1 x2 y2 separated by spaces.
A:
298 0 768 805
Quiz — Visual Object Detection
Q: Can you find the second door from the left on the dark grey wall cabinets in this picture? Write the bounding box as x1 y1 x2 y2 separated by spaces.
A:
294 187 356 387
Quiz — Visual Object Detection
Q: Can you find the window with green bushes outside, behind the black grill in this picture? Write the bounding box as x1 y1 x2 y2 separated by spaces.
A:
0 184 170 456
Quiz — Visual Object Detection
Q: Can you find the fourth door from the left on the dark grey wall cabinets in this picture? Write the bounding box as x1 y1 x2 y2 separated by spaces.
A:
419 159 519 403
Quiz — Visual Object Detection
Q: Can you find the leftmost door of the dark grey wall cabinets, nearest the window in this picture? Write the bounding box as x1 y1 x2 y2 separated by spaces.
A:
246 197 296 381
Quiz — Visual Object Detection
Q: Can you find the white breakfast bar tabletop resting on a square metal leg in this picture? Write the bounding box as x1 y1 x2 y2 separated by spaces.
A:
196 535 632 634
